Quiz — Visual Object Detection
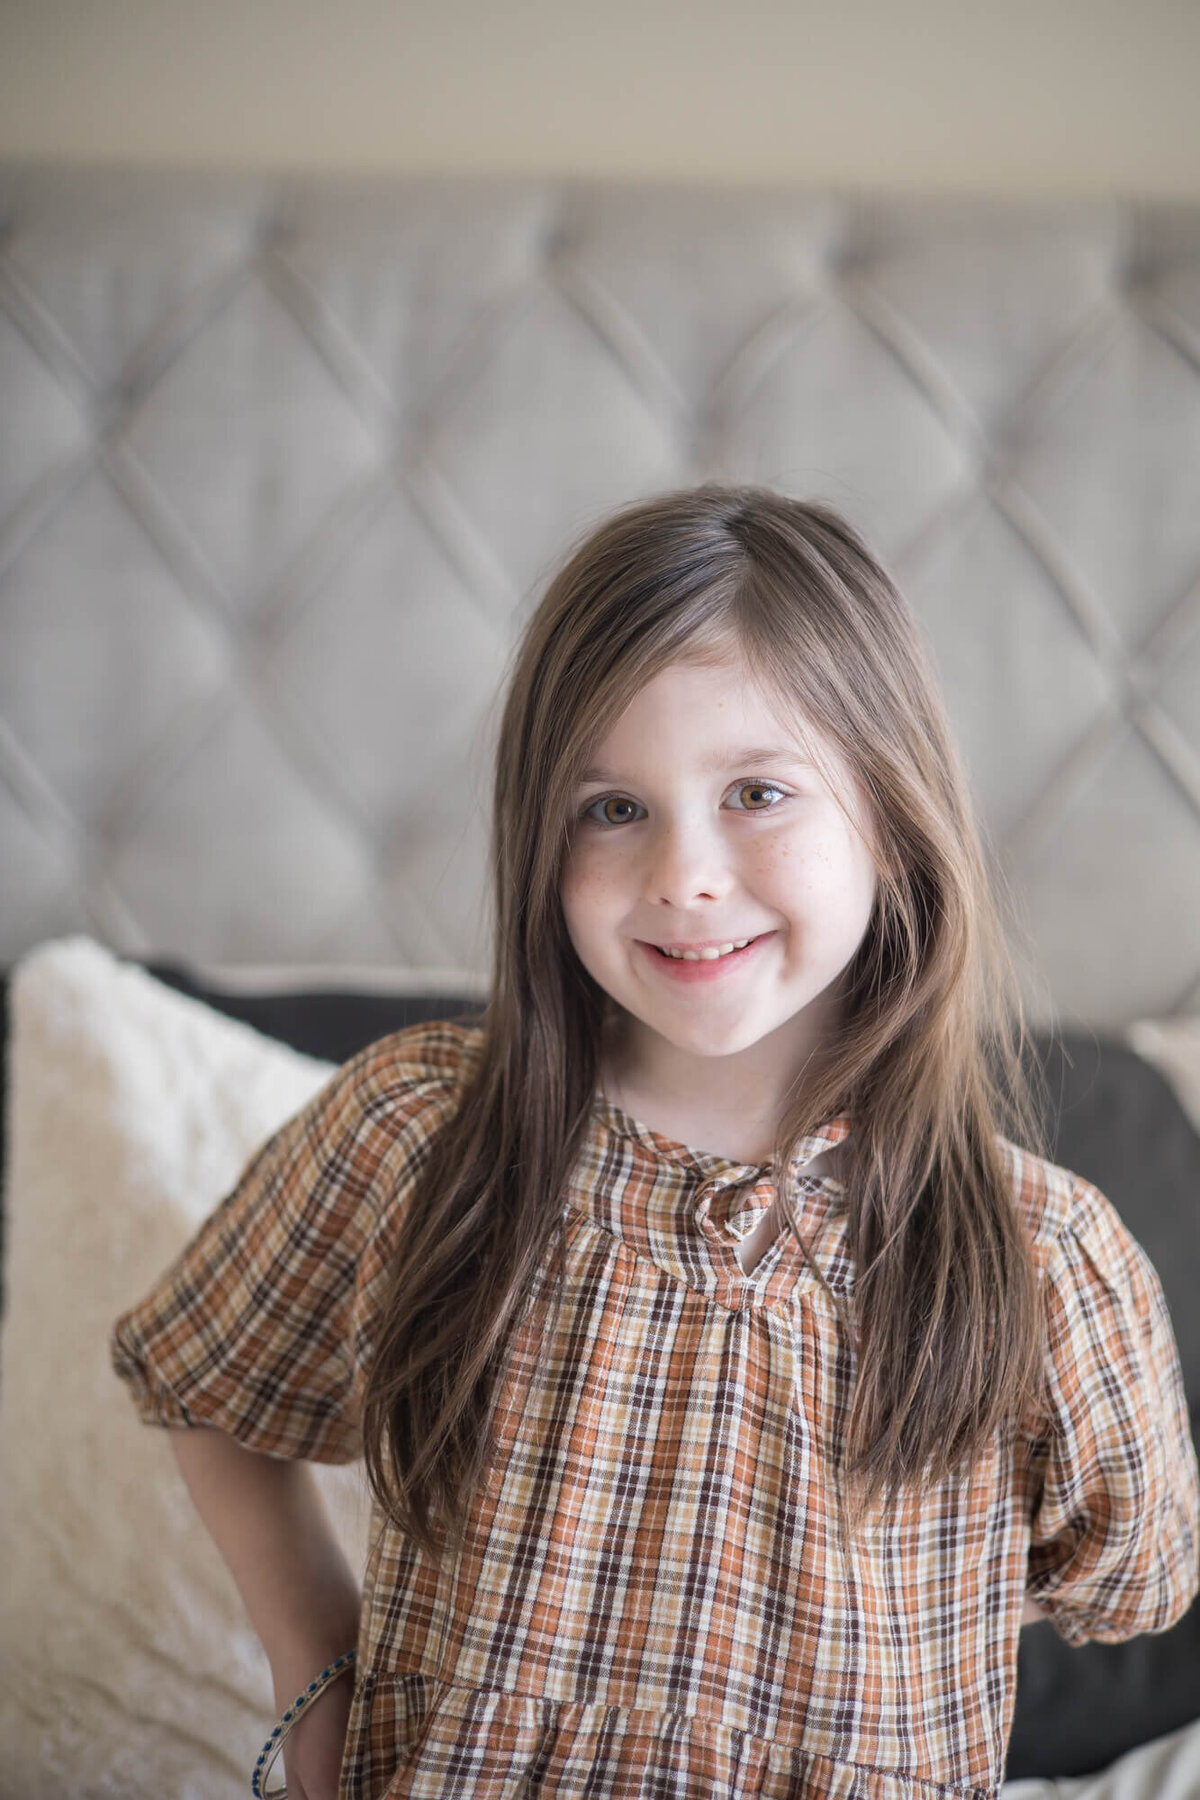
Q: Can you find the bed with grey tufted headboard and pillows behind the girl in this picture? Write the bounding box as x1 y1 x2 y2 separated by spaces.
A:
0 166 1200 1800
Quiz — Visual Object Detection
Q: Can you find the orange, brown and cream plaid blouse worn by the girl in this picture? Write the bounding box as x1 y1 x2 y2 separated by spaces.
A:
113 1024 1198 1800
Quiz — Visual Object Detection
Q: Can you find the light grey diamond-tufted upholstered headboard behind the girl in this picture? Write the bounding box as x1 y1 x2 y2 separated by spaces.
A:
0 166 1200 1028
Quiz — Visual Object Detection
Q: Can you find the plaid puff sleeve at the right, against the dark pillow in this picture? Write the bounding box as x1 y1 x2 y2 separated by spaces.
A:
1027 1181 1200 1643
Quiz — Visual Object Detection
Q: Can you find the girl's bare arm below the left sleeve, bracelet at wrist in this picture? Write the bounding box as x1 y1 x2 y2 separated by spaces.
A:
169 1427 362 1800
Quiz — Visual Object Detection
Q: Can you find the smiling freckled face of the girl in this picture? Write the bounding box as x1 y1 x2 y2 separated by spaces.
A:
561 646 876 1078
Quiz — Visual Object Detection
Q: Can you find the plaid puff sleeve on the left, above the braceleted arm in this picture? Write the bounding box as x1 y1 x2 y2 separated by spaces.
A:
110 1026 461 1462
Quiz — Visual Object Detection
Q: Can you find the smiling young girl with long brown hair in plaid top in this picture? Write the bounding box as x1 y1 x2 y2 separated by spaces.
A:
113 486 1198 1800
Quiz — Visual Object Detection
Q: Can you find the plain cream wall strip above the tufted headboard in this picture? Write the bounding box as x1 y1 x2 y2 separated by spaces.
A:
0 0 1200 194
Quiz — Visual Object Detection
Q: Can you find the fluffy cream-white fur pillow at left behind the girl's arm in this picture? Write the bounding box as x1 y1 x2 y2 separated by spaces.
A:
0 938 369 1800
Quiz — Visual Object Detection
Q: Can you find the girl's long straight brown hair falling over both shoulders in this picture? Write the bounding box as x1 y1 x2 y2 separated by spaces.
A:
363 486 1043 1552
